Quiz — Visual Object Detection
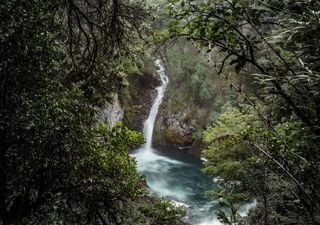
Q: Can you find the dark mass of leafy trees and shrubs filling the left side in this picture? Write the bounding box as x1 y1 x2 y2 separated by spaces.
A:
0 0 182 225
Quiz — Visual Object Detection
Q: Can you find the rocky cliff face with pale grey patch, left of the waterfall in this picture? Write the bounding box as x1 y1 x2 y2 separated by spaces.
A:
97 63 160 131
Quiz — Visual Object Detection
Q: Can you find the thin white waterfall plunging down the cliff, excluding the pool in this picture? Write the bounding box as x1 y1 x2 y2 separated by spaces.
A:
143 59 169 150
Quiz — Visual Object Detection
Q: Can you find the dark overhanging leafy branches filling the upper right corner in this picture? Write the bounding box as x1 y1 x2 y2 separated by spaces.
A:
169 0 319 132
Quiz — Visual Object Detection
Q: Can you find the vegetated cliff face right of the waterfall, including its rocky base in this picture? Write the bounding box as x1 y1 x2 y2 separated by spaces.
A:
153 40 218 152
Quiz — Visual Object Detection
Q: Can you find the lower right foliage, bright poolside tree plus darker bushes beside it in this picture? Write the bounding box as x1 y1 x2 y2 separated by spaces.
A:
203 105 316 224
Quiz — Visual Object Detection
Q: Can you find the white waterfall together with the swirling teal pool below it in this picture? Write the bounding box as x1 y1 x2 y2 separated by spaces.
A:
131 60 254 225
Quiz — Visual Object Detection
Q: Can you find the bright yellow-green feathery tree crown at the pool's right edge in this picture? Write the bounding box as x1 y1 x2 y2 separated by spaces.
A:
203 107 262 181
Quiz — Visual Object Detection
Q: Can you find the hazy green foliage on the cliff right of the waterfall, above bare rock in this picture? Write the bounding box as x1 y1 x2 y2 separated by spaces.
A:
160 40 238 148
